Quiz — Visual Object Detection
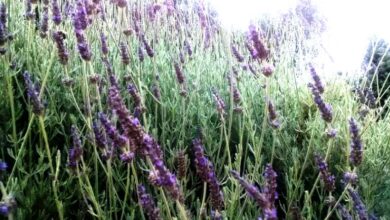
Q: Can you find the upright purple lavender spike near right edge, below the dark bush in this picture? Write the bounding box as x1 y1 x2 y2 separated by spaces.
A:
349 118 363 166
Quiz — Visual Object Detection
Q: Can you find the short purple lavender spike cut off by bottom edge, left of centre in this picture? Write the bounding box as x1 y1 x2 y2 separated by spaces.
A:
137 185 162 220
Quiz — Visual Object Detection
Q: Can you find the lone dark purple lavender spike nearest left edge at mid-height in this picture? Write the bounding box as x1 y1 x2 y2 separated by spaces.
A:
23 71 44 115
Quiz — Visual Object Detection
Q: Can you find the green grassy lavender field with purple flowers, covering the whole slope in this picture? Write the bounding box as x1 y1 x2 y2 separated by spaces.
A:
0 0 390 219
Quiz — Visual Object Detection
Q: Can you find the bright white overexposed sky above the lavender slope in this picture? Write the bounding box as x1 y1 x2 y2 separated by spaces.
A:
209 0 390 74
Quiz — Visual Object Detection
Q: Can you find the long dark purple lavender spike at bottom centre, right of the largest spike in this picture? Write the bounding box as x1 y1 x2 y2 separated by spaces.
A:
192 138 224 211
